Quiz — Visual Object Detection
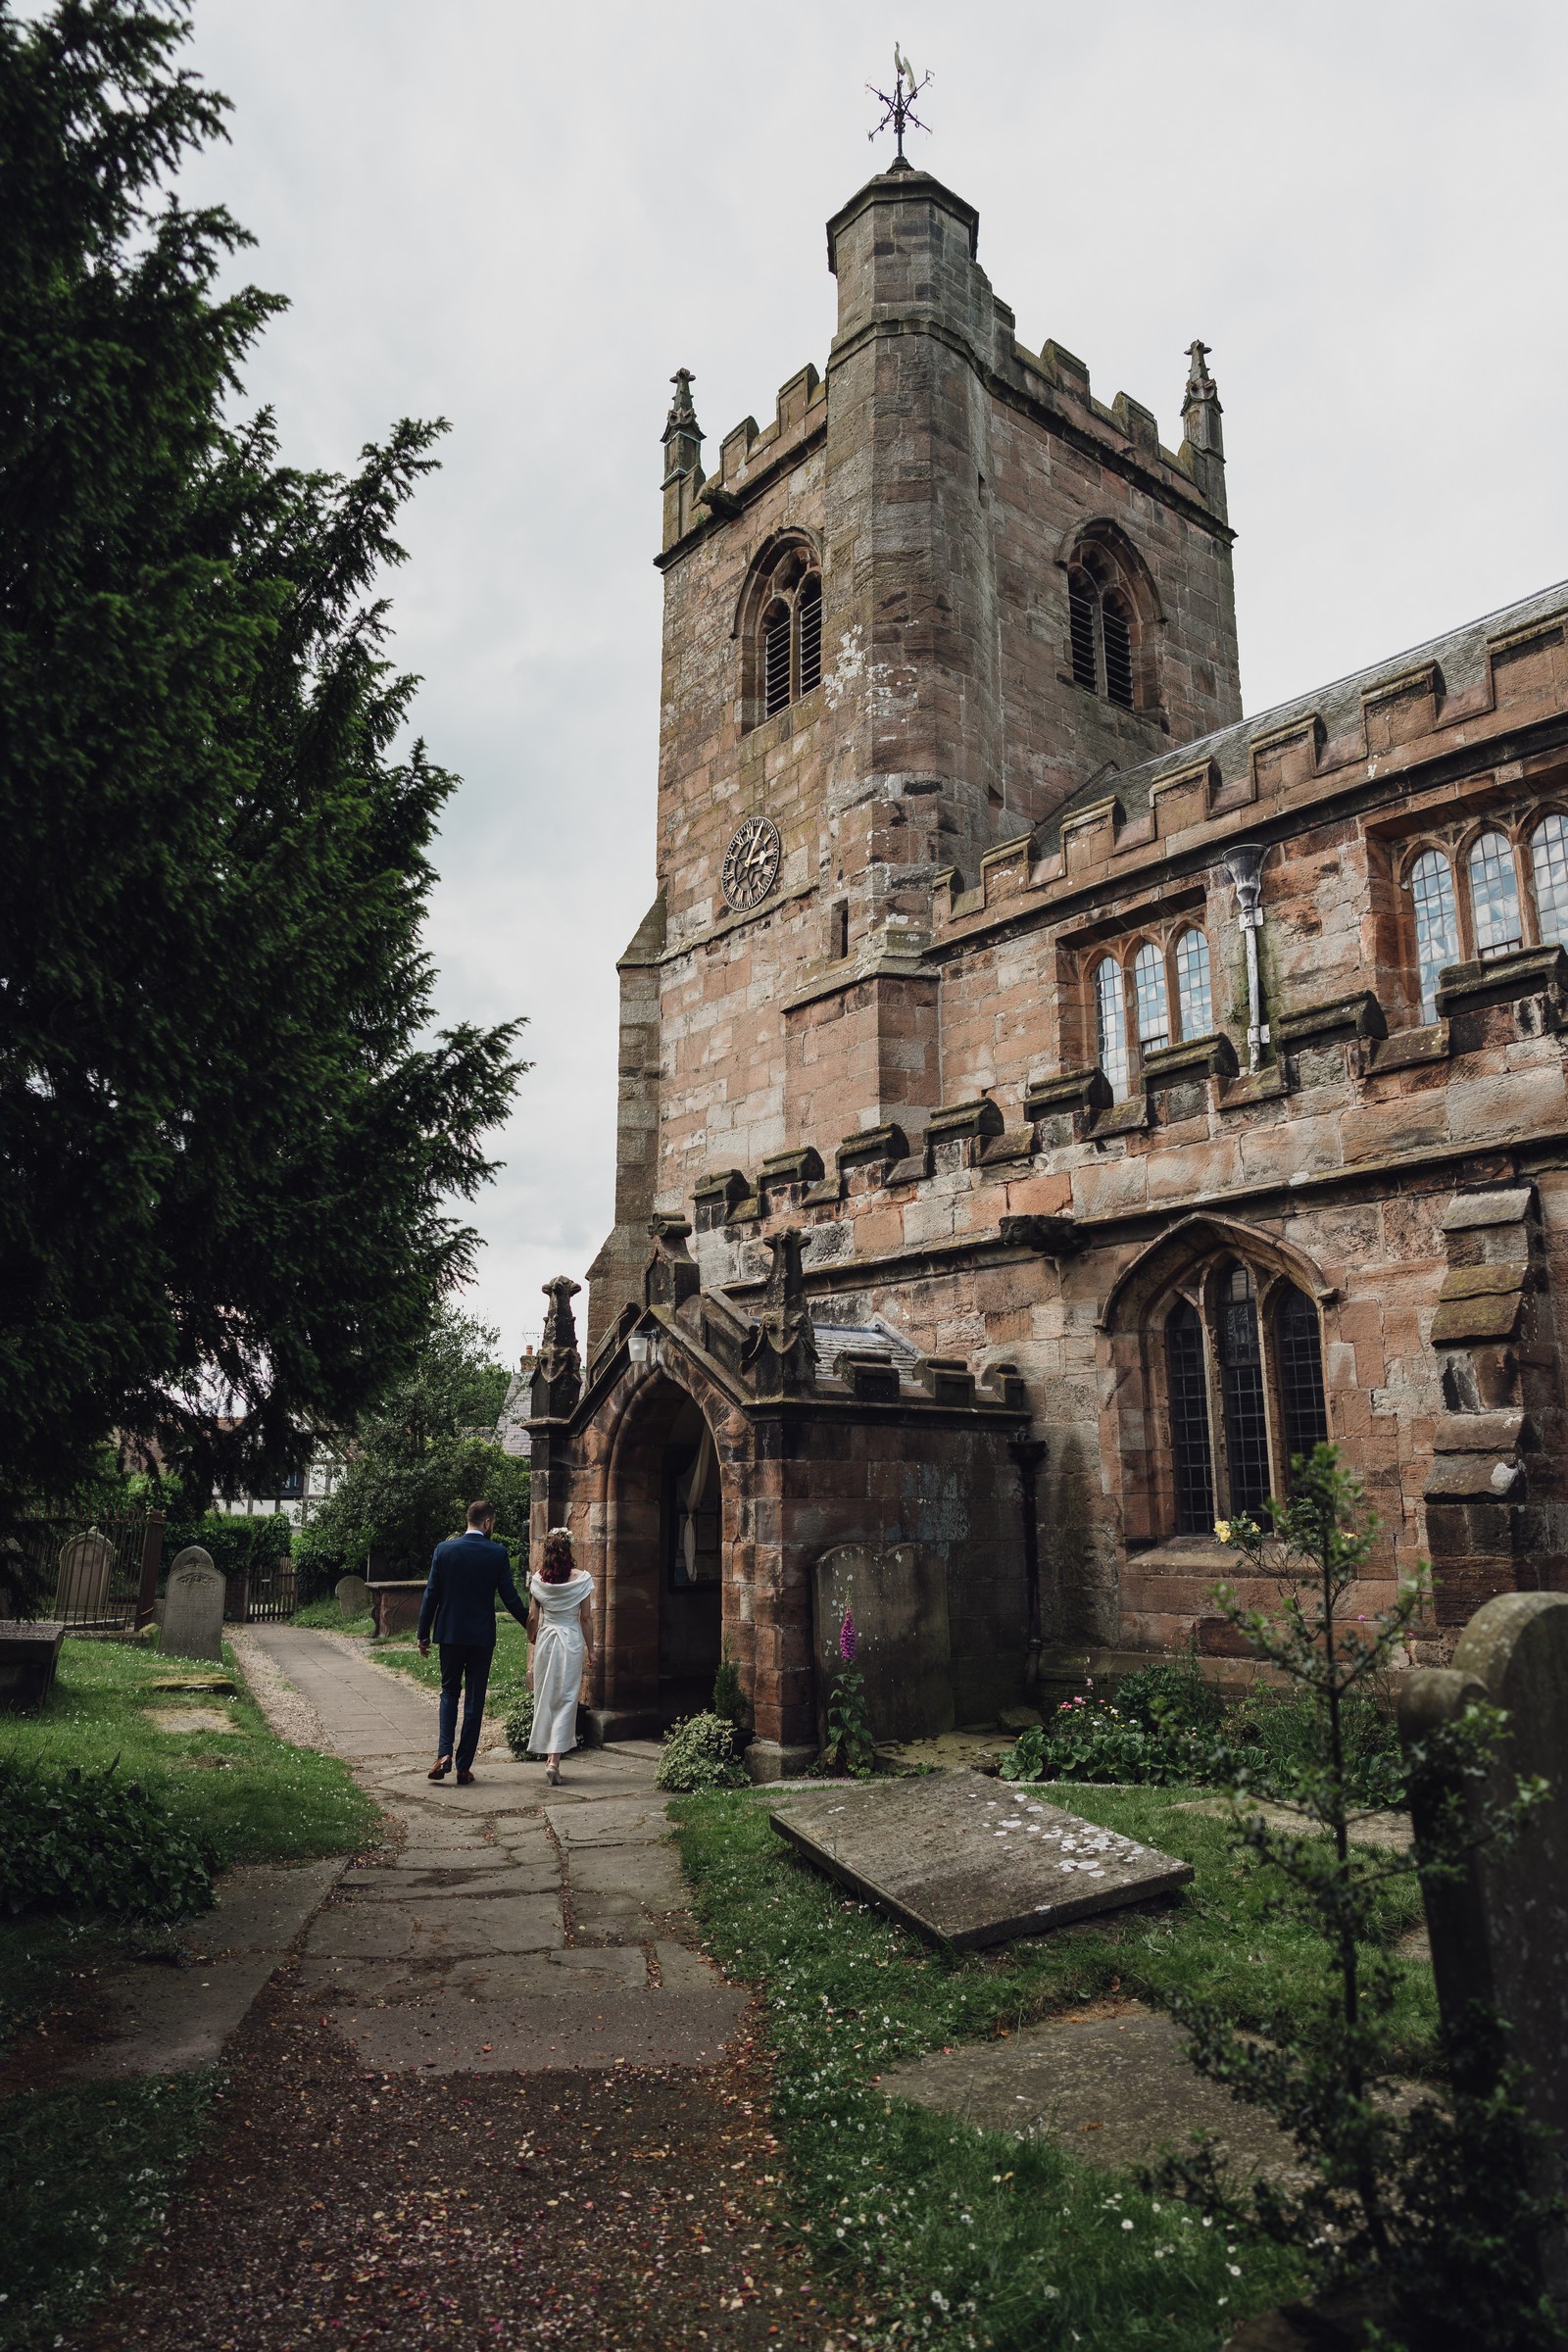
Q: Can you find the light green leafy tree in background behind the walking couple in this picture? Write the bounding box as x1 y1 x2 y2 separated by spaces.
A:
294 1307 529 1581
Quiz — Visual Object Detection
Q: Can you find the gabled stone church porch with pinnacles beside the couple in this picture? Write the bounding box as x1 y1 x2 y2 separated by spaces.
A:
529 1218 1042 1781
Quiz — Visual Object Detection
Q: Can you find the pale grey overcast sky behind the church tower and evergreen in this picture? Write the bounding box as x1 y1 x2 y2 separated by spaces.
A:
169 0 1568 1354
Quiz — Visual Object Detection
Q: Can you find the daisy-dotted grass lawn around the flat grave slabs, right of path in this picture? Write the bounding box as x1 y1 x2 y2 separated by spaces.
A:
672 1783 1437 2352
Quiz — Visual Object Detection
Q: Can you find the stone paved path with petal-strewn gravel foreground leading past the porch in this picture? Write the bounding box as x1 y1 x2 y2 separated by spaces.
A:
73 1628 858 2352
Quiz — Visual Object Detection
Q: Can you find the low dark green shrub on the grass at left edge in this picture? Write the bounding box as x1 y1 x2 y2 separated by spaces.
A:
0 1757 212 1919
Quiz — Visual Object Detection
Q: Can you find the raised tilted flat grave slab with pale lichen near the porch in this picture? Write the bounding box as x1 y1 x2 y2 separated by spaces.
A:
771 1771 1192 1952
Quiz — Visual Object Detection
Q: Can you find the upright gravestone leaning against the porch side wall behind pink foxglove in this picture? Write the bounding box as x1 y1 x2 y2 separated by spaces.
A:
813 1543 953 1740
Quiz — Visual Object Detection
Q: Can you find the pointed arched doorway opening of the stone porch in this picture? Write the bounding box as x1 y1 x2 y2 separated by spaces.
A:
604 1374 724 1727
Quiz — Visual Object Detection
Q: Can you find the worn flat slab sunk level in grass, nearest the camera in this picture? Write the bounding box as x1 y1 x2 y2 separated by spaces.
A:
879 2001 1302 2182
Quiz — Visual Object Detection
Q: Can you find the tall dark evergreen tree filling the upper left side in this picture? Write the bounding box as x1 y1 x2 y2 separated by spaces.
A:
0 0 524 1531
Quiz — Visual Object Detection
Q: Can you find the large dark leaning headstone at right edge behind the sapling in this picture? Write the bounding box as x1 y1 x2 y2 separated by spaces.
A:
1398 1592 1568 2305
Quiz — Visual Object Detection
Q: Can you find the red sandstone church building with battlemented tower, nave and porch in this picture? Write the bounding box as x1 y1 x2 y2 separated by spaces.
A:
529 165 1568 1778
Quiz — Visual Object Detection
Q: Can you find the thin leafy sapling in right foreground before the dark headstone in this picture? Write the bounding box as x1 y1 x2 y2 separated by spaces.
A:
1159 1446 1563 2352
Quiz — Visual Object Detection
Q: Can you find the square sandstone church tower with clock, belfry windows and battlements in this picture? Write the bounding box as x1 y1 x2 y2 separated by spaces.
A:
588 158 1242 1346
